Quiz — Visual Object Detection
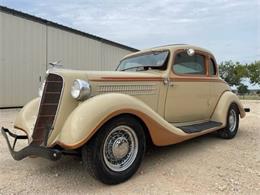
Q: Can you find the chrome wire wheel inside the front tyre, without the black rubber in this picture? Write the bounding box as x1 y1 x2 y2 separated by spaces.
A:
103 125 138 172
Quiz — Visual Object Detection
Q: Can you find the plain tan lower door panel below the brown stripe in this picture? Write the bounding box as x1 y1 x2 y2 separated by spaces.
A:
165 82 210 123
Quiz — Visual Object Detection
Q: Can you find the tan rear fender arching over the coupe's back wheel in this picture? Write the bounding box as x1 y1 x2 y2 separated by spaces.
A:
211 91 246 126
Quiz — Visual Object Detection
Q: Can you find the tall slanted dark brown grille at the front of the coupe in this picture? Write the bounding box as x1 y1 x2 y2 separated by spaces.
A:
32 74 63 145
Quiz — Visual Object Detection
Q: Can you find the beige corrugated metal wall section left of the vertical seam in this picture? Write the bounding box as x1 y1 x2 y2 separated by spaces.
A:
0 12 46 107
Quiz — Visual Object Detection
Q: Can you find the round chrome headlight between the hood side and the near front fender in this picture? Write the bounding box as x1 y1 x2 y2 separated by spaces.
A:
71 79 91 100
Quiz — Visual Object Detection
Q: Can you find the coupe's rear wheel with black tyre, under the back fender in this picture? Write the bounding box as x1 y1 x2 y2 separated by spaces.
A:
218 104 239 139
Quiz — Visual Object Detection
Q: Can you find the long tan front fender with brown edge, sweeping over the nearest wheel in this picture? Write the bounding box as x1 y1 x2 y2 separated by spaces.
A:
52 93 221 149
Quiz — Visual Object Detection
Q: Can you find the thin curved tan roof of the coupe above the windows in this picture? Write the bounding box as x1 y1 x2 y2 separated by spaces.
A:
124 44 214 58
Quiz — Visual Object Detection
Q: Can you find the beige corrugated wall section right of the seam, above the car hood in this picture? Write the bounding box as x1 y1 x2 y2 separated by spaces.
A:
47 27 130 70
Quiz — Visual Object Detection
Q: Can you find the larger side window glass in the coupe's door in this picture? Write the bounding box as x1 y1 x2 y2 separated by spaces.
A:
173 51 206 75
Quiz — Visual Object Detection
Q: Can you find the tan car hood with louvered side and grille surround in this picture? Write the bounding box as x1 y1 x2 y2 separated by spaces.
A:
44 69 163 144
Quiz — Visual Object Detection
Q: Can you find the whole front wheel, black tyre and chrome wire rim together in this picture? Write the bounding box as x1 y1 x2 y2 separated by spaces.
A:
82 116 146 184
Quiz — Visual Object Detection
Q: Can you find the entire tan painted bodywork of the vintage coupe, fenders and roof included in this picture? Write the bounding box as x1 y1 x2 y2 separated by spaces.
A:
15 45 245 149
